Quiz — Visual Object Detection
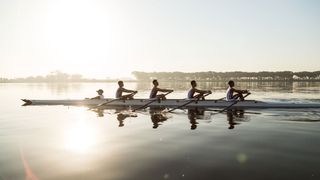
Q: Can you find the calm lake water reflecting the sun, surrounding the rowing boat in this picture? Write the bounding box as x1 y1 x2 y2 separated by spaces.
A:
0 83 320 180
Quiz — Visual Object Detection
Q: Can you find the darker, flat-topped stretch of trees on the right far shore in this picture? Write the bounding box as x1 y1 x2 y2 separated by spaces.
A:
132 71 320 81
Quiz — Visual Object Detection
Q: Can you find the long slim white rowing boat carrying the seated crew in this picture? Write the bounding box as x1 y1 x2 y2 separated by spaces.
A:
22 99 320 108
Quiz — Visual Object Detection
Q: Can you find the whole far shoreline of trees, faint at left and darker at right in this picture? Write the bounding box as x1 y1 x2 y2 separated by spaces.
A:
0 71 320 83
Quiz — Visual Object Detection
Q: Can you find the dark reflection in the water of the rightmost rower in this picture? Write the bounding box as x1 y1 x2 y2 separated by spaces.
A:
226 109 248 129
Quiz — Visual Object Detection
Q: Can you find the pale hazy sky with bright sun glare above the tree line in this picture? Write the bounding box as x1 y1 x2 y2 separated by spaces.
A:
0 0 320 78
